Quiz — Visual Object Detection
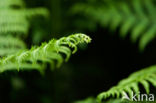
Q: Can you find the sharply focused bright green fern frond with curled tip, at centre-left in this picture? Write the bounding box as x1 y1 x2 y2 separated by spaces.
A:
0 34 91 72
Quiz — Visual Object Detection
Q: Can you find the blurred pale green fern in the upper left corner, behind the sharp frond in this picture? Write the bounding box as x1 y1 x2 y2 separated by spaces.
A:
0 0 49 56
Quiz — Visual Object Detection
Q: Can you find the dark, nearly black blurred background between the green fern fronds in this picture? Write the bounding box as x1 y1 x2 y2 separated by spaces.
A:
0 0 156 103
